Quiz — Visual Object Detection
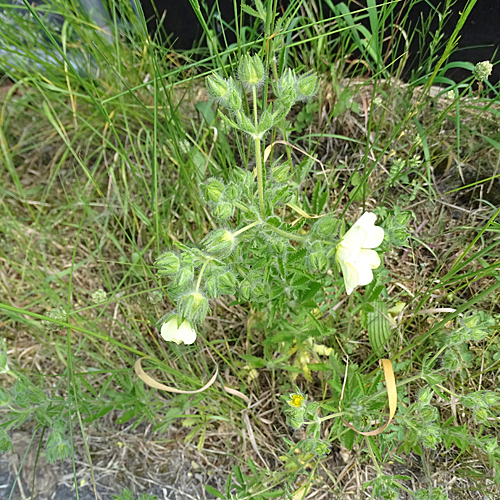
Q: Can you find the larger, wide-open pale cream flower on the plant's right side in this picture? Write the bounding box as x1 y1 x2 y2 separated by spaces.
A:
335 212 384 295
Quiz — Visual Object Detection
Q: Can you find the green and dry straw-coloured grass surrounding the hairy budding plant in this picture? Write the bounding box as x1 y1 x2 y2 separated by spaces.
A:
0 0 500 499
